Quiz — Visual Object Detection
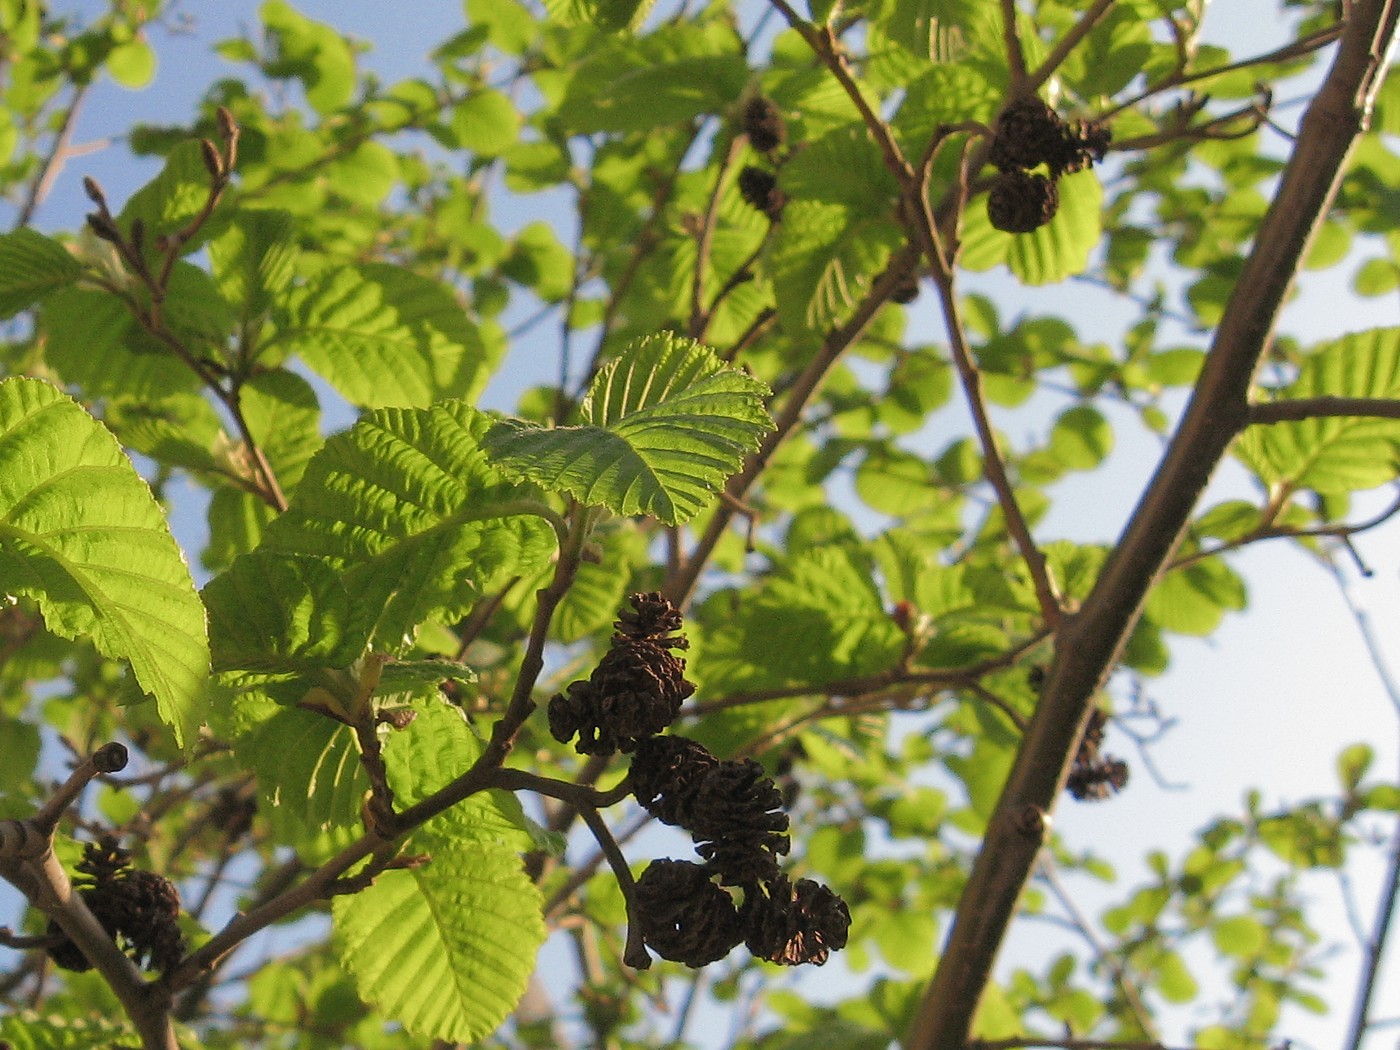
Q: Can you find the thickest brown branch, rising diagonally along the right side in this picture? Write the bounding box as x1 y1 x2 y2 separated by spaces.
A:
904 0 1397 1050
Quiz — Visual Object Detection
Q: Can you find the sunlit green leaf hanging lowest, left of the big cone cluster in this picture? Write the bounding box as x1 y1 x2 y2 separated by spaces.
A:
332 837 545 1042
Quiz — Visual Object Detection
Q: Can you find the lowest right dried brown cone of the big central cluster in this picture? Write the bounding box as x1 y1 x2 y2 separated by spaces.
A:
739 875 851 966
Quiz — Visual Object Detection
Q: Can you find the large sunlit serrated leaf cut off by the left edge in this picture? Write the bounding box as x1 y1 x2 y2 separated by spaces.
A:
0 378 209 746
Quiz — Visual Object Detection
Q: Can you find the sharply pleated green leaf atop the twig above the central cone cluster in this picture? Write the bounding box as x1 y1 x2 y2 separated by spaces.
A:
486 333 773 525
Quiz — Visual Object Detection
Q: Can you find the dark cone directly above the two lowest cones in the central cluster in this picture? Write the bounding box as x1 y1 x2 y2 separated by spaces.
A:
686 759 791 886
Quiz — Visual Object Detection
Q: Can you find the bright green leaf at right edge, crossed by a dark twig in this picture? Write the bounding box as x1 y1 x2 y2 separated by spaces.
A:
1235 328 1400 494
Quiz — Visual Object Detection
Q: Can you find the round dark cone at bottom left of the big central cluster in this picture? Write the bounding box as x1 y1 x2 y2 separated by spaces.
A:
633 861 743 967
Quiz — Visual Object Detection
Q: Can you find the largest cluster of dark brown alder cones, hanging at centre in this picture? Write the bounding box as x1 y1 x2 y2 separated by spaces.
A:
549 594 851 966
